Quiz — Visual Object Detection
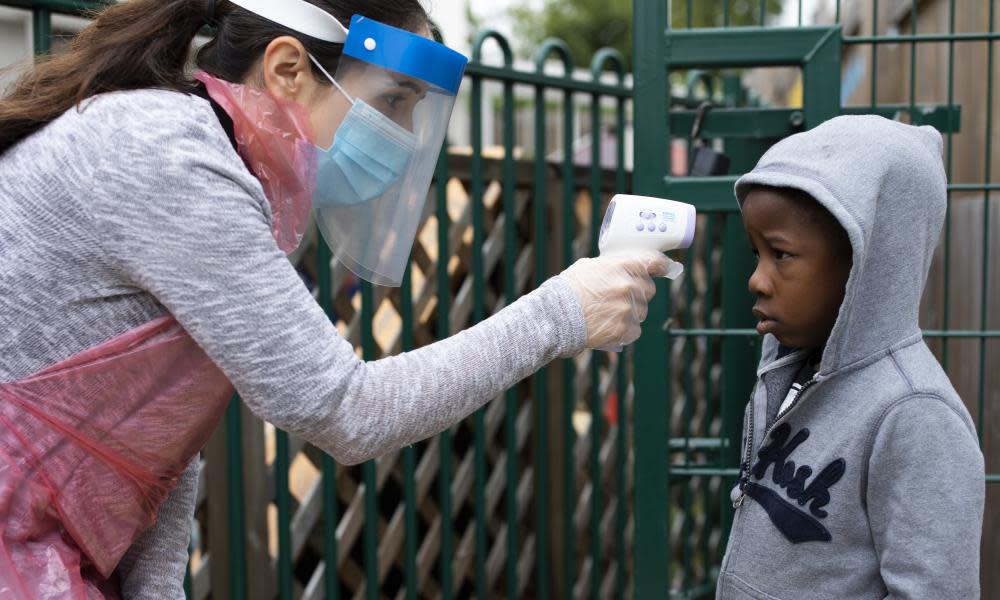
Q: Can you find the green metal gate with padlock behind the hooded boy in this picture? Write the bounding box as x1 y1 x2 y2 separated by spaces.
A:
634 0 1000 598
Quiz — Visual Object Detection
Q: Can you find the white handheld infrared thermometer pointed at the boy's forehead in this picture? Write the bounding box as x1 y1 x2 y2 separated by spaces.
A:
598 194 698 279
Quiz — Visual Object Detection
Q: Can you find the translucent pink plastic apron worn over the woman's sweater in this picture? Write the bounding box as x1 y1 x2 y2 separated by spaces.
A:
0 73 315 600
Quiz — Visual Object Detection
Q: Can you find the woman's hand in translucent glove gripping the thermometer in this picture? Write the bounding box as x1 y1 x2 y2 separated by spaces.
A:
560 250 684 351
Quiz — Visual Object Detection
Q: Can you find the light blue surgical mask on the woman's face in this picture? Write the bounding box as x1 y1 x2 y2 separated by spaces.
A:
315 95 417 207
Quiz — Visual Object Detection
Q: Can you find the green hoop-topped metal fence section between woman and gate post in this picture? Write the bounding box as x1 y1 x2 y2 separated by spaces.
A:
0 0 632 598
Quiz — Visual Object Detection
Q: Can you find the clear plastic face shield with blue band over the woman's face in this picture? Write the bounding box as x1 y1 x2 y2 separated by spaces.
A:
313 16 467 286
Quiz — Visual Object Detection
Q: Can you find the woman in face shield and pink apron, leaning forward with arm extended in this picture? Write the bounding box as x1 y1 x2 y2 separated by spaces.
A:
0 0 669 598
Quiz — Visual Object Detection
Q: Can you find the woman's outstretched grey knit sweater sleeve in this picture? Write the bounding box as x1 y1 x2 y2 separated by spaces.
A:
89 94 586 464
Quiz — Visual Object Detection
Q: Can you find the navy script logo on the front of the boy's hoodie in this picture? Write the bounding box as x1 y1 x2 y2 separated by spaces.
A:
745 423 847 544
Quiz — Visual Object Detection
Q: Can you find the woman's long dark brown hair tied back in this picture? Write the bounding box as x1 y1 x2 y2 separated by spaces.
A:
0 0 429 154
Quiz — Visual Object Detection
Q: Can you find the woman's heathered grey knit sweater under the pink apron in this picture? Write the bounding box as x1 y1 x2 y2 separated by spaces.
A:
0 90 586 599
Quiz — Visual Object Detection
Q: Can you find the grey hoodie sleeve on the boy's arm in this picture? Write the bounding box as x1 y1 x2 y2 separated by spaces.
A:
866 396 985 600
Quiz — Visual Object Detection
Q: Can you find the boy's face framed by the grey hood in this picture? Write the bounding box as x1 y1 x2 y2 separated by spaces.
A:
743 189 851 349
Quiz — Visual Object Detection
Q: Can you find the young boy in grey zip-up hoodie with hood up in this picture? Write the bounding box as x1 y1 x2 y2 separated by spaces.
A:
717 116 985 600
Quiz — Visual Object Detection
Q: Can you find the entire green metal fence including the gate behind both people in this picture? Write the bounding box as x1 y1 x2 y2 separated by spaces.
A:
7 0 1000 598
